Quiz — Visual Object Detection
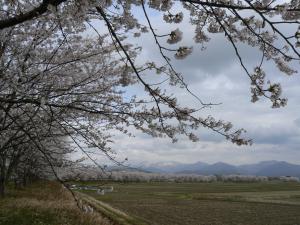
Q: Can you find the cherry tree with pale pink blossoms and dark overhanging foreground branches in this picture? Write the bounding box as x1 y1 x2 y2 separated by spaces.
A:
0 0 300 195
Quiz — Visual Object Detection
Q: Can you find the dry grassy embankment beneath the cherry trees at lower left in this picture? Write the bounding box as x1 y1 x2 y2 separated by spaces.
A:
0 182 112 225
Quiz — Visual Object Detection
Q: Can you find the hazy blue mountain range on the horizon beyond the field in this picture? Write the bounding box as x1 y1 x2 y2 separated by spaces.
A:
139 161 300 177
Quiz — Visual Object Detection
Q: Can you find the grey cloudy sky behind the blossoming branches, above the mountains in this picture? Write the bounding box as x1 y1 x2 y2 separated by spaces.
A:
91 6 300 164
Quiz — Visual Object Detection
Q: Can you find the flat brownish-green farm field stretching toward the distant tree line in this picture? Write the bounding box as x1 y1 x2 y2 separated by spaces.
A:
85 182 300 225
